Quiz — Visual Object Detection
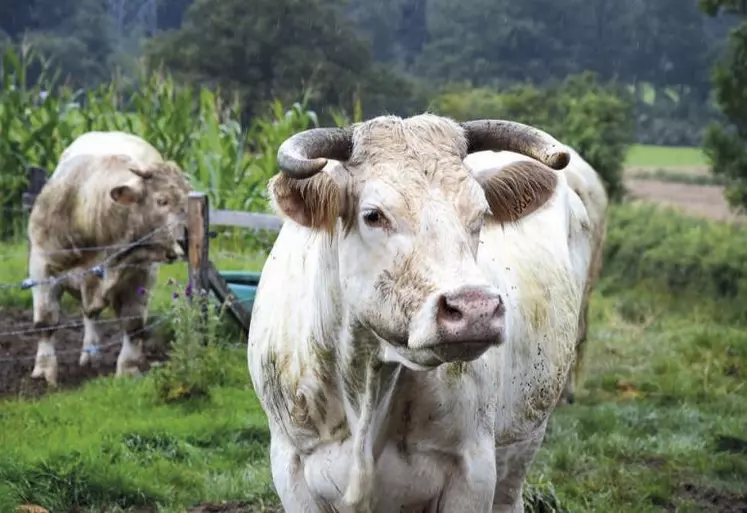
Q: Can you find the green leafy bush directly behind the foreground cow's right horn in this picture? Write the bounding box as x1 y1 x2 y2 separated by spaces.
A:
433 73 635 200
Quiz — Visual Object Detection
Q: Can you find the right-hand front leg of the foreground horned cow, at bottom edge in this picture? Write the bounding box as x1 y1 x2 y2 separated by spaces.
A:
436 438 496 513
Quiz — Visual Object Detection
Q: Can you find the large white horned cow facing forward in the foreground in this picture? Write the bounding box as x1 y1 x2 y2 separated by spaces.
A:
247 114 590 513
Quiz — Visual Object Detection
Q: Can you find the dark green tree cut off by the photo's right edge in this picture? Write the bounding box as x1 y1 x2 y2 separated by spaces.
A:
700 0 747 210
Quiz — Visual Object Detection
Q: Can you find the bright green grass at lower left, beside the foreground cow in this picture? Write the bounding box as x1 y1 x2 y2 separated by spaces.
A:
0 348 276 512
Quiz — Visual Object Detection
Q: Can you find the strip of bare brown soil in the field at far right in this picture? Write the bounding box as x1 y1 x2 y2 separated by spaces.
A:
625 180 747 222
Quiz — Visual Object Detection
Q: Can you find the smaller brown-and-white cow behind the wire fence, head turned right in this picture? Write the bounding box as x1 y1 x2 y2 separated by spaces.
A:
28 132 192 385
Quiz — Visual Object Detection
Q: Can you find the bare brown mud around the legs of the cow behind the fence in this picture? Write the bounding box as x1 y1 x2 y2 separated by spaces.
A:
0 307 167 397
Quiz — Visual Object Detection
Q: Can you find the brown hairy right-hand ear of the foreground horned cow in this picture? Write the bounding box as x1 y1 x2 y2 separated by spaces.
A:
475 161 559 224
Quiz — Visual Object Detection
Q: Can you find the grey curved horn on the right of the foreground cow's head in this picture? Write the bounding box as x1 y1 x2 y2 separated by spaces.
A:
461 119 571 170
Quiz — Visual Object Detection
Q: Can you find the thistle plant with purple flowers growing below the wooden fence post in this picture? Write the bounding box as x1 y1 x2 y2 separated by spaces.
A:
153 282 227 402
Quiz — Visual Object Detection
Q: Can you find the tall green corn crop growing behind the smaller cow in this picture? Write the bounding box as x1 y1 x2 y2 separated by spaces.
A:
0 43 317 242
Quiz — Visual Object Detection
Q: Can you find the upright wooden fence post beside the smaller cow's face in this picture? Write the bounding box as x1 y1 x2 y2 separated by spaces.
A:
187 192 210 294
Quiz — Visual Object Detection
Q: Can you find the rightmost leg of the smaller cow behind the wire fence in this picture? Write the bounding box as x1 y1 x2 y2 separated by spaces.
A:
113 297 148 376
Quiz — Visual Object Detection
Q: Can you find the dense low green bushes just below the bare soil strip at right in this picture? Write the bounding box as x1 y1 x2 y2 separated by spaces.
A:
602 200 747 318
